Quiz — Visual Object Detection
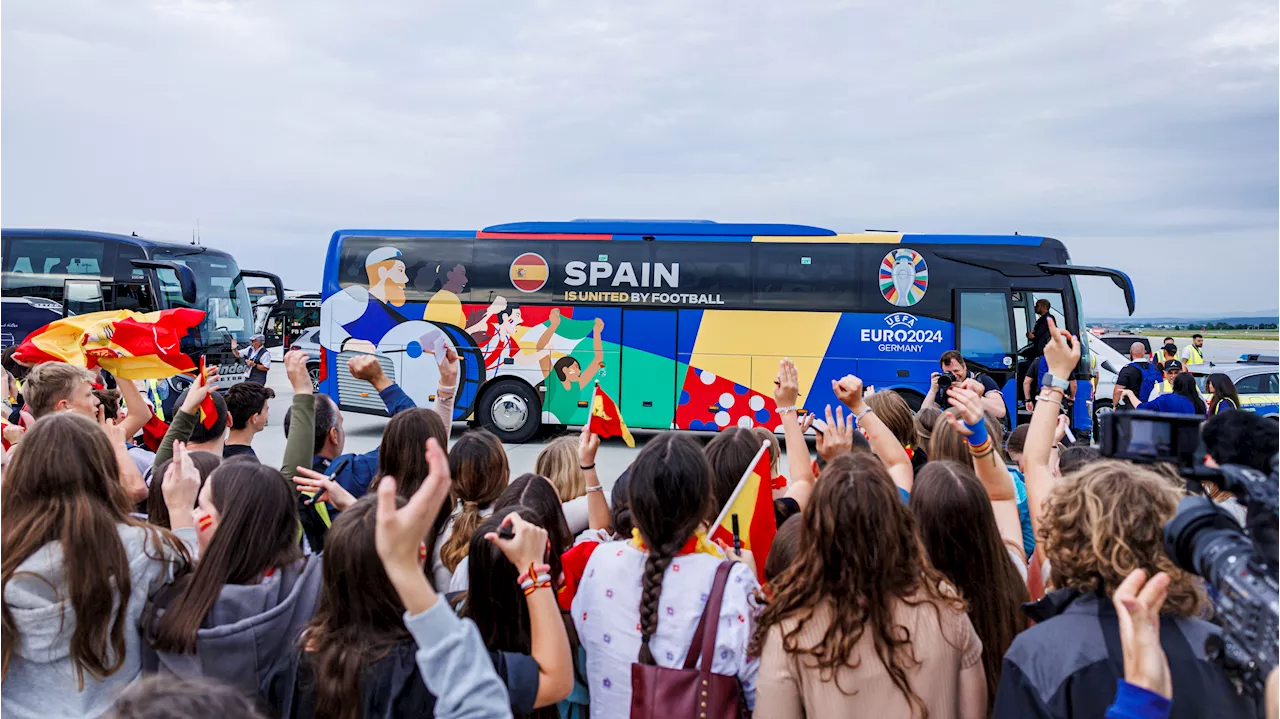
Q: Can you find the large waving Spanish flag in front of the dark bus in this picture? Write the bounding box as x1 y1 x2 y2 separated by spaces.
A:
14 308 205 380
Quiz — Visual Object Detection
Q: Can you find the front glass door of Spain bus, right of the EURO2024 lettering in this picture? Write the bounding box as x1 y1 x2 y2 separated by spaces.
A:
955 288 1018 417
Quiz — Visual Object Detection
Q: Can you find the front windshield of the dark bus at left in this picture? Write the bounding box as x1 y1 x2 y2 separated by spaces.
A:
154 249 253 343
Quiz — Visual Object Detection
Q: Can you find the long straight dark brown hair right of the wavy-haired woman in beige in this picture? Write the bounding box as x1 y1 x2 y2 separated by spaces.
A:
908 461 1030 711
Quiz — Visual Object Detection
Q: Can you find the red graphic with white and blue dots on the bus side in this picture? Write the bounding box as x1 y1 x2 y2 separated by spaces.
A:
676 367 782 431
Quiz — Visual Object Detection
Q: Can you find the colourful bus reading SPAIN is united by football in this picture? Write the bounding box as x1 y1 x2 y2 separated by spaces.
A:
319 220 1134 443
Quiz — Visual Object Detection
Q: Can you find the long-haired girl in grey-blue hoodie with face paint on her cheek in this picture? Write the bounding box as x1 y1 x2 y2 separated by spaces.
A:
145 461 321 692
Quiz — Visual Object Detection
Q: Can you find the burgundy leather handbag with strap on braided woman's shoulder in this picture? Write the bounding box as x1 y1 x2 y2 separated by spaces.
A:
631 562 750 719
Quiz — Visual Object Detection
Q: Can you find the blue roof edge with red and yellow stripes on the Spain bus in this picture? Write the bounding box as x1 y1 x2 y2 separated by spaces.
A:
334 220 1057 247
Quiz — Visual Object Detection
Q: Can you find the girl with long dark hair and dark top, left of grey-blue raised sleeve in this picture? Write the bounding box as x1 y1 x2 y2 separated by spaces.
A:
262 495 435 719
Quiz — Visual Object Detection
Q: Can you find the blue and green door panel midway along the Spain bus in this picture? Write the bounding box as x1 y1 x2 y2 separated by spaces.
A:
618 310 681 430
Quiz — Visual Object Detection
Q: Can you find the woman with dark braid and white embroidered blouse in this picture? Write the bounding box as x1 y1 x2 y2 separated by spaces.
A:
572 432 759 716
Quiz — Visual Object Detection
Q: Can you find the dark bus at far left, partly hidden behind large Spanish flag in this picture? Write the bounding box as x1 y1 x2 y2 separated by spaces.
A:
0 228 283 398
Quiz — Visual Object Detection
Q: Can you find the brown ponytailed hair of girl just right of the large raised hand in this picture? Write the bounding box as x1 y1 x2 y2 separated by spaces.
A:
432 430 511 594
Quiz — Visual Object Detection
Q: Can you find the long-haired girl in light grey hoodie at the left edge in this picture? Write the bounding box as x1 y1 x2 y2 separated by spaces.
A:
0 412 200 719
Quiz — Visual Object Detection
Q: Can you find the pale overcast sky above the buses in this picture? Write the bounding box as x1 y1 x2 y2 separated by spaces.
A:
0 0 1280 316
